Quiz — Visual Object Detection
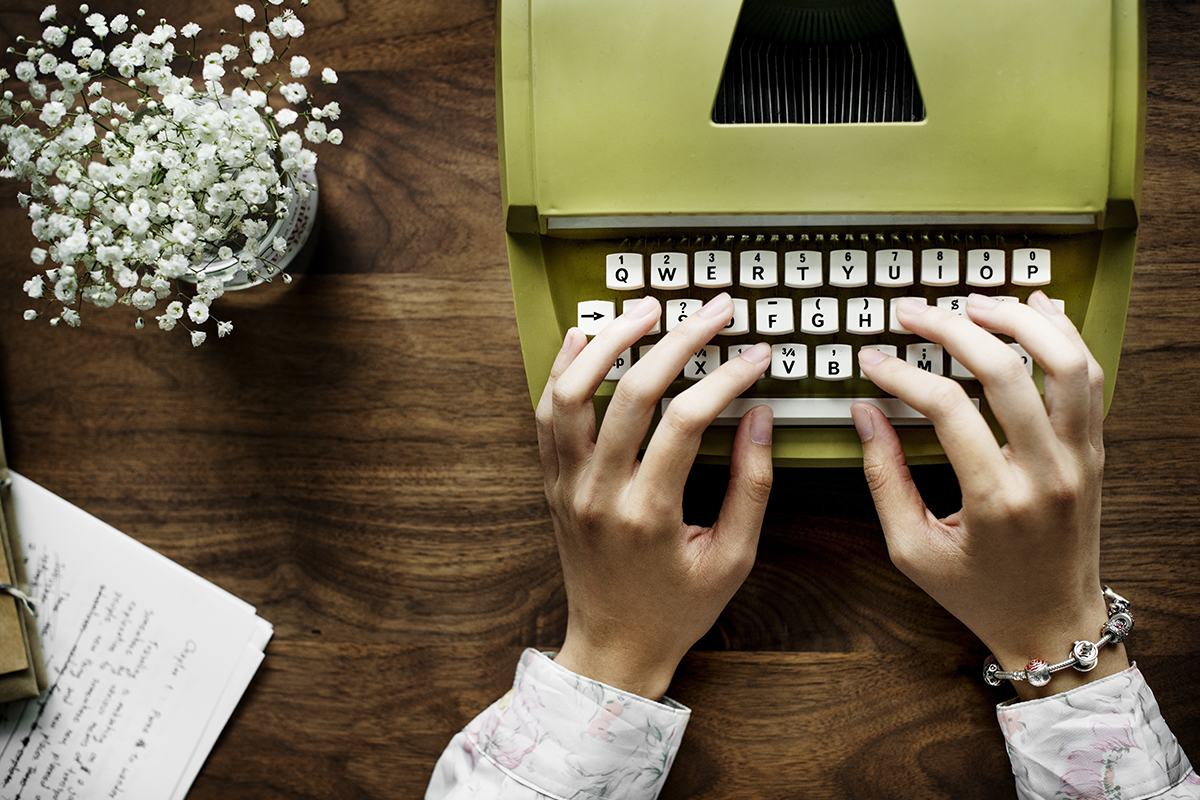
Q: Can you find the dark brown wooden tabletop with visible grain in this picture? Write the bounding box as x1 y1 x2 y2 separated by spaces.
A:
0 0 1200 800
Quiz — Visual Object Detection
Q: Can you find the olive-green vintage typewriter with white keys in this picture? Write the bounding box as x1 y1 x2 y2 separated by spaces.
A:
497 0 1146 467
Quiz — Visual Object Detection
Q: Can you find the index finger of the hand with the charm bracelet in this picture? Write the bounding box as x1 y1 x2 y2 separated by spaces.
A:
858 347 1009 495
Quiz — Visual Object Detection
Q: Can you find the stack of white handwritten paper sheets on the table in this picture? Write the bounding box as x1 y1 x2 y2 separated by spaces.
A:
0 473 272 800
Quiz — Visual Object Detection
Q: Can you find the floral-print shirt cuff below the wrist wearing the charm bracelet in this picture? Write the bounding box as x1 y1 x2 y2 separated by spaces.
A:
996 664 1200 800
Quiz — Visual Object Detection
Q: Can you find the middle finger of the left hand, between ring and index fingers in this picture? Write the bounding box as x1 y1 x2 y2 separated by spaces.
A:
595 293 734 480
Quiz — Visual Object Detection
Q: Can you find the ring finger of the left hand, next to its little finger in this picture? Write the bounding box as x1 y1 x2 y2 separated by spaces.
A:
551 297 659 469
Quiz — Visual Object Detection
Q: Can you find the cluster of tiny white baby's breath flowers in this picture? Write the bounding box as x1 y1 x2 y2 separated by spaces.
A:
0 0 342 347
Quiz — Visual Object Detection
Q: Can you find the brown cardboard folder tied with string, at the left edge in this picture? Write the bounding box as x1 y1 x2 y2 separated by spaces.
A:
0 419 47 703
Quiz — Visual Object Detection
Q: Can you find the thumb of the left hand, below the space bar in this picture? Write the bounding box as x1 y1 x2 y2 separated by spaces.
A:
713 405 775 579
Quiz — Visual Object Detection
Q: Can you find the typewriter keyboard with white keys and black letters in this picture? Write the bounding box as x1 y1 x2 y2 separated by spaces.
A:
575 234 1069 426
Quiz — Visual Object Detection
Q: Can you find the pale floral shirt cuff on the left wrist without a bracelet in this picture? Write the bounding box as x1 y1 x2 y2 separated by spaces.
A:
425 650 691 800
